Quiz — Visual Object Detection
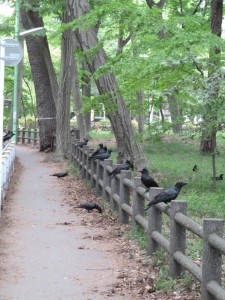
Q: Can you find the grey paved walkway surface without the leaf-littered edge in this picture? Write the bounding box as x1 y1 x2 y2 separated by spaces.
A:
0 146 127 300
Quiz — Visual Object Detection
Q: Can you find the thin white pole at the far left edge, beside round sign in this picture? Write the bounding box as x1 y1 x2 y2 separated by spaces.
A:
0 41 5 205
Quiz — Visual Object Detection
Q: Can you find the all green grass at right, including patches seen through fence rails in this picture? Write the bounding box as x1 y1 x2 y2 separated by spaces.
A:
88 128 225 292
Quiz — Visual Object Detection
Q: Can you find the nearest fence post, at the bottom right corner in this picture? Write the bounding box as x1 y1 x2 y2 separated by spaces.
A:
201 219 224 300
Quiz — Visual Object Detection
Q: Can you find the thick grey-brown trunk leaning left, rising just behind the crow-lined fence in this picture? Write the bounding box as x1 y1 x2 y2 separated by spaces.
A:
65 0 146 168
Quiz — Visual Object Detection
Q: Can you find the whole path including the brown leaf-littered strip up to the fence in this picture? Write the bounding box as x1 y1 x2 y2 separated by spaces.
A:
0 146 198 300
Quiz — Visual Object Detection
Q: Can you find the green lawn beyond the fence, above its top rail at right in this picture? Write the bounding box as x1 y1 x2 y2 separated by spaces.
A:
145 136 225 219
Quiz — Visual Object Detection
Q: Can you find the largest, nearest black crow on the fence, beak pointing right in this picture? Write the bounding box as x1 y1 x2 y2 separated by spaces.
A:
145 181 187 210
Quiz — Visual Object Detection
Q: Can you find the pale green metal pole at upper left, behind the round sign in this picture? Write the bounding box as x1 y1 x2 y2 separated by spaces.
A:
12 0 20 141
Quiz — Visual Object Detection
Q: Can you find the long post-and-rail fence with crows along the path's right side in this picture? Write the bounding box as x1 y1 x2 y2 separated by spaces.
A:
71 142 225 300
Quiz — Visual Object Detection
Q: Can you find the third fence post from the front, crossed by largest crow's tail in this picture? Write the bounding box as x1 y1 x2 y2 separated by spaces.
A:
147 188 163 255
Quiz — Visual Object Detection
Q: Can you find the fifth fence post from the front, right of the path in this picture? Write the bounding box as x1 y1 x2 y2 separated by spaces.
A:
119 170 131 224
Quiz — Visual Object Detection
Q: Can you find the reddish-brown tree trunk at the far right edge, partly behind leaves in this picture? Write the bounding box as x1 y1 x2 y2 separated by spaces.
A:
200 0 223 154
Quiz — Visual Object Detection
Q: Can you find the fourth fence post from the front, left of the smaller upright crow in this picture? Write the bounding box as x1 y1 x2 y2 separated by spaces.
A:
132 177 145 225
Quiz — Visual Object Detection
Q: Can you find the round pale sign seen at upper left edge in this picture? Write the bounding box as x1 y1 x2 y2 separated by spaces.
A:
3 39 23 66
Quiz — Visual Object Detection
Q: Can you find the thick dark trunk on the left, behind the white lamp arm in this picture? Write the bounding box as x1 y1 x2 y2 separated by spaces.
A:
21 4 56 150
